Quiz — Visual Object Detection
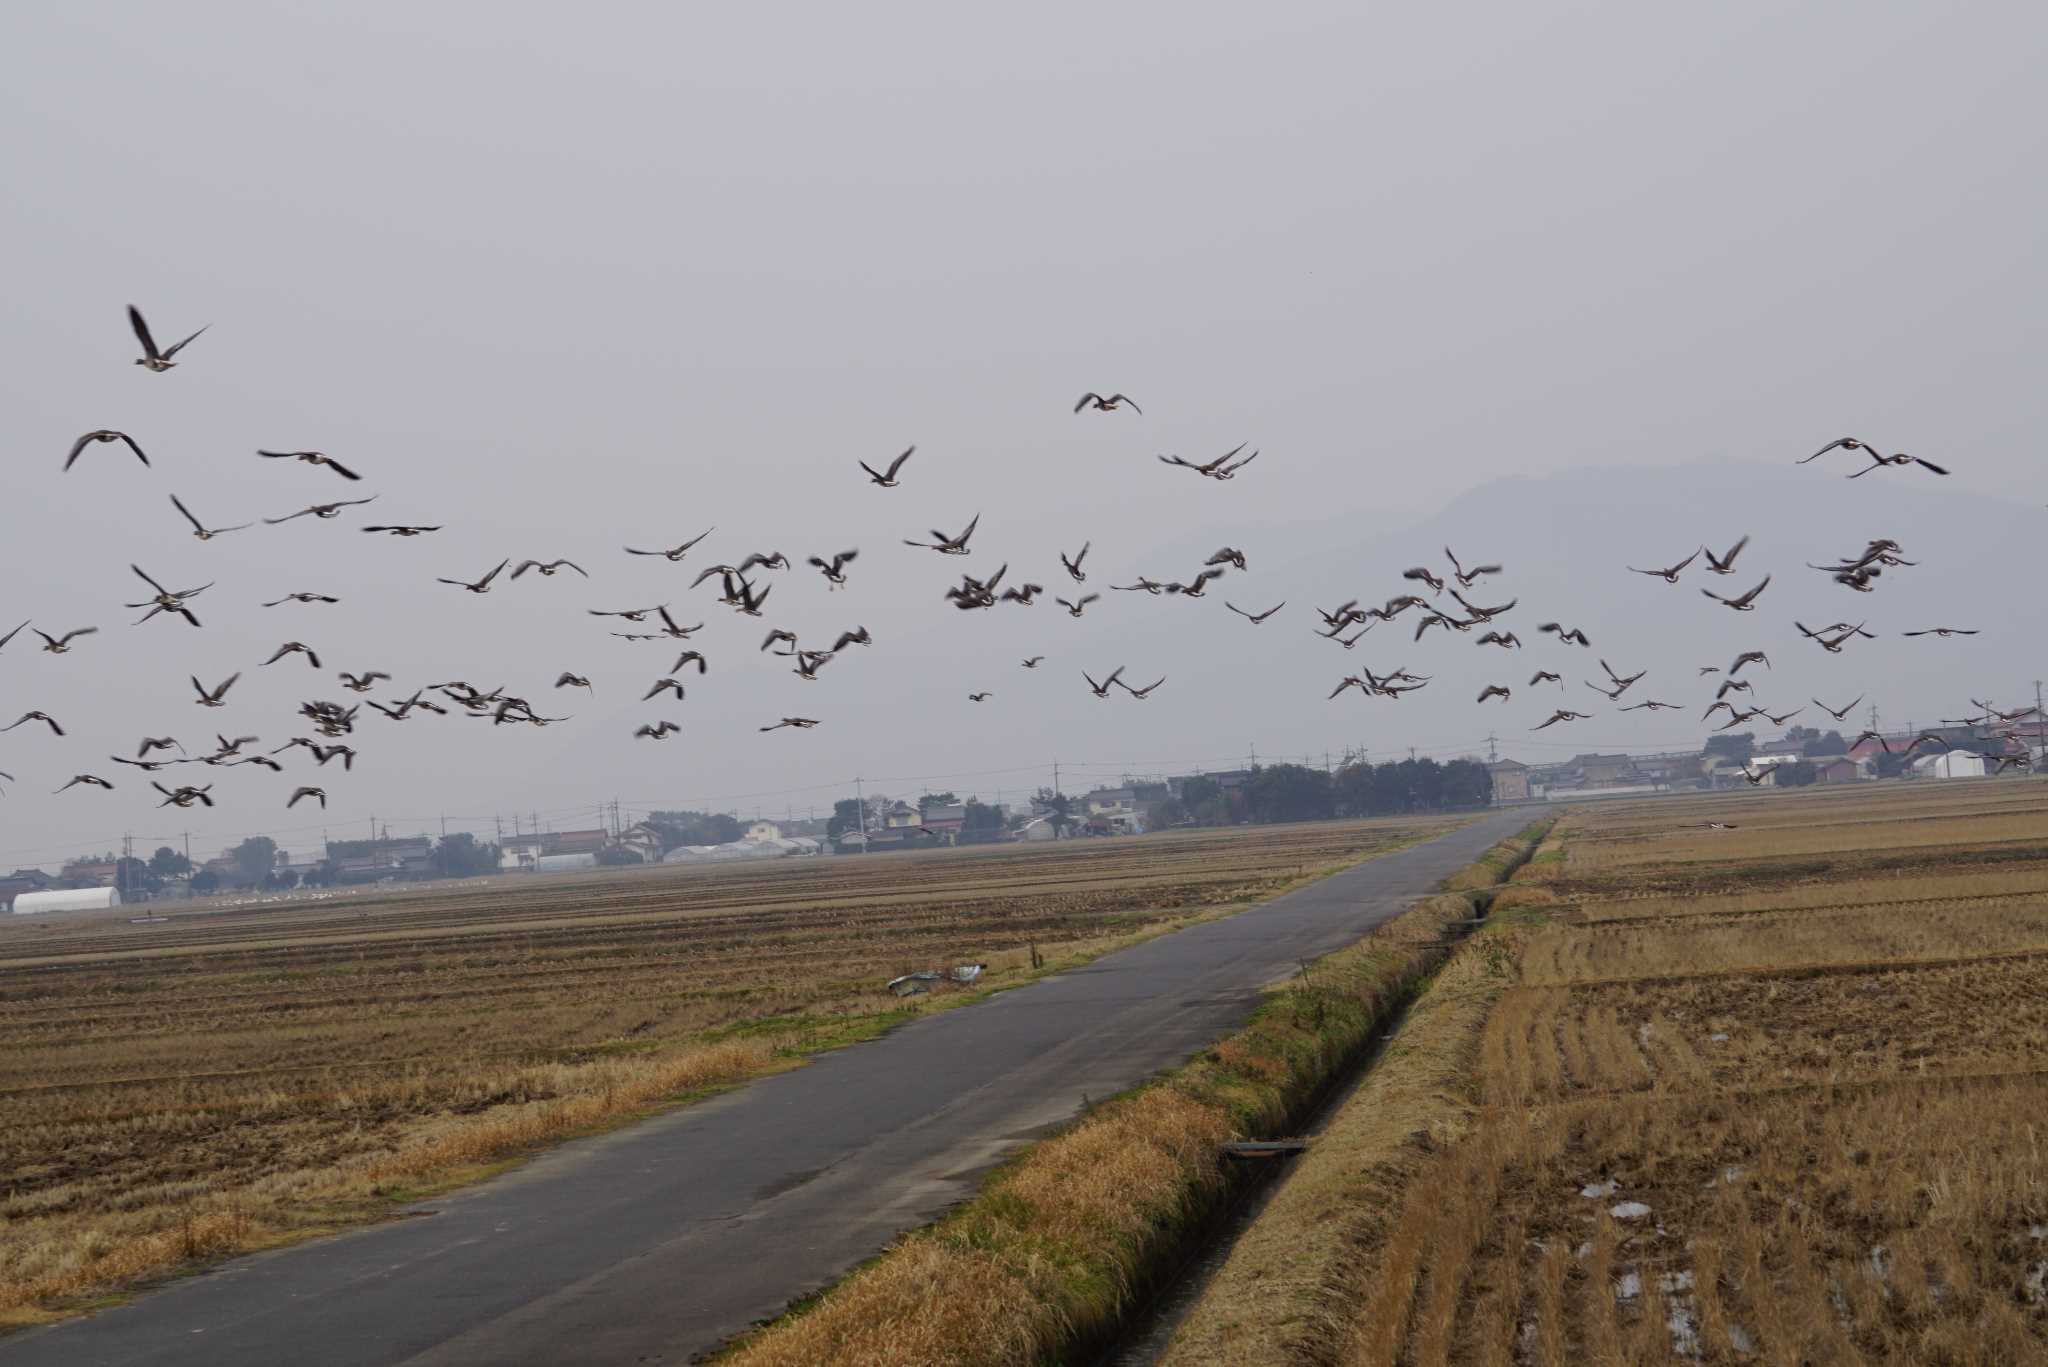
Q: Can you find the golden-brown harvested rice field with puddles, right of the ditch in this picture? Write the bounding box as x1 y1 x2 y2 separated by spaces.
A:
1165 779 2048 1367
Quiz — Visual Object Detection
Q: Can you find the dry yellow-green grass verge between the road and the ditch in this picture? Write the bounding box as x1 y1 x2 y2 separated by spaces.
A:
723 819 1530 1367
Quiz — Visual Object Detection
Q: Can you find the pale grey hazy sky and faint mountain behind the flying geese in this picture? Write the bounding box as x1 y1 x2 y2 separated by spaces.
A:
0 2 2048 865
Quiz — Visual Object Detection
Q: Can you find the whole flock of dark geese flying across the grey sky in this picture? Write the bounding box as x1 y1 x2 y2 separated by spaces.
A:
0 305 2028 807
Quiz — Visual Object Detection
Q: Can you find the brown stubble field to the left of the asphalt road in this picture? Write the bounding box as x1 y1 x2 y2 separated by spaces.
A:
0 820 1444 1322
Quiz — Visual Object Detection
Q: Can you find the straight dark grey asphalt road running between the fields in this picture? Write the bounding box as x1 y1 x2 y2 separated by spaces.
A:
0 814 1526 1367
